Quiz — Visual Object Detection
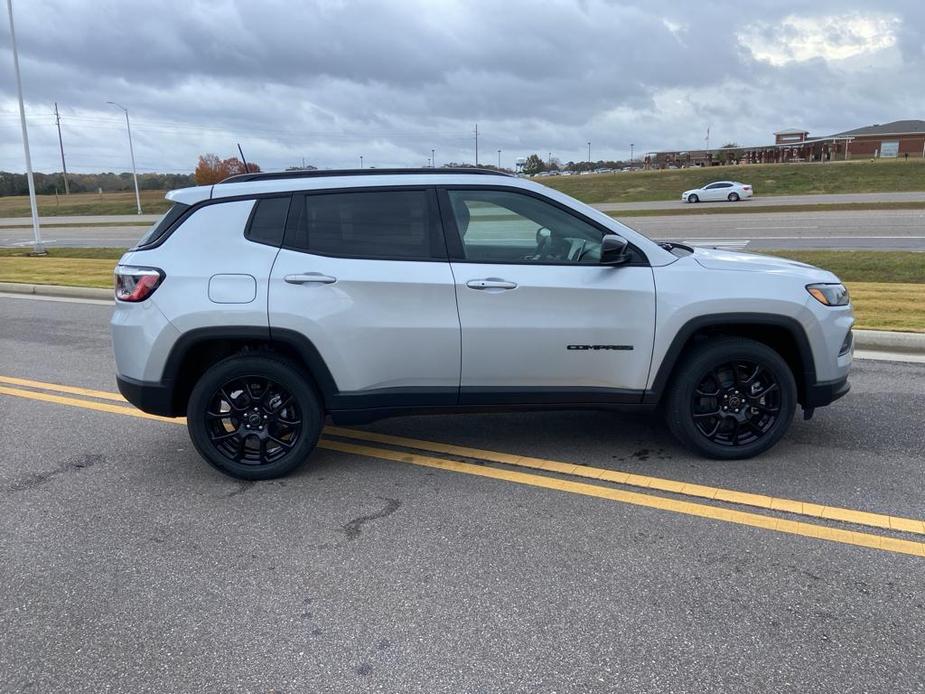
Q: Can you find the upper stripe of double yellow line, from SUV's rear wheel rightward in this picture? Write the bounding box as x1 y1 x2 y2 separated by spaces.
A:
324 427 925 535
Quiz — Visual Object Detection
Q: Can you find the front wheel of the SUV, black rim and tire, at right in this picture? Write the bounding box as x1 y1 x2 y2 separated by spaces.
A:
665 338 797 460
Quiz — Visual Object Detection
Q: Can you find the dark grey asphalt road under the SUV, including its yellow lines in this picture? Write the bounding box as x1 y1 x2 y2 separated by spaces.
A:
0 299 925 692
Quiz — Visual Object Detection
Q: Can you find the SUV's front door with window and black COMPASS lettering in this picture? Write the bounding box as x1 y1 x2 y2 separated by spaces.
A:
441 188 655 404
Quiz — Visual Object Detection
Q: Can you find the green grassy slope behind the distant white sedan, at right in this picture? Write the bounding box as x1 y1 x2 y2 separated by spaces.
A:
535 159 925 203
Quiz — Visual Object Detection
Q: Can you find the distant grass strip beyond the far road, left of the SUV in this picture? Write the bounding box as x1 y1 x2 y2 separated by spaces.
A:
0 190 170 217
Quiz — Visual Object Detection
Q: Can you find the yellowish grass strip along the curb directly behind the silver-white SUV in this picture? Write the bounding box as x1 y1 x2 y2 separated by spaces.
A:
0 248 925 332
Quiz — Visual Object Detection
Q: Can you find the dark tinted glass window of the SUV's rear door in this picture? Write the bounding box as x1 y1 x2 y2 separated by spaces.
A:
286 190 446 260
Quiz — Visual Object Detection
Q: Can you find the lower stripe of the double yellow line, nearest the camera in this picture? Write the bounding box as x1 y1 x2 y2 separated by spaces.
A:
0 378 925 557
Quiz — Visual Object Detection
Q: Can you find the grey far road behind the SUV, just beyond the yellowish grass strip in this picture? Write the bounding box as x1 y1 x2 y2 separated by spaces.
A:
0 210 925 251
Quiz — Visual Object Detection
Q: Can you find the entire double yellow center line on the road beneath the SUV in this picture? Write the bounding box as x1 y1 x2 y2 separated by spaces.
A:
0 376 925 557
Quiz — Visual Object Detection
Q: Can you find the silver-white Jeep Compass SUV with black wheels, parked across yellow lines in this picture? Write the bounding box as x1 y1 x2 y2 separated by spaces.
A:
112 169 854 479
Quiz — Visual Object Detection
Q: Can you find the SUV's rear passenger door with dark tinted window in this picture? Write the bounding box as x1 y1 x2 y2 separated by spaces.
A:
269 188 460 409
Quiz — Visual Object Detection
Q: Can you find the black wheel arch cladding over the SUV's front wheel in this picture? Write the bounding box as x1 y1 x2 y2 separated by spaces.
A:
643 313 816 404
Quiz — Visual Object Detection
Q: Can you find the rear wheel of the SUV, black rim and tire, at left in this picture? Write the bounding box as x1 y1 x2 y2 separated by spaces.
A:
186 353 324 480
